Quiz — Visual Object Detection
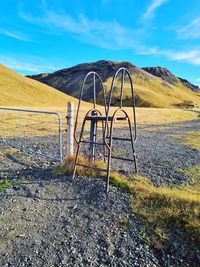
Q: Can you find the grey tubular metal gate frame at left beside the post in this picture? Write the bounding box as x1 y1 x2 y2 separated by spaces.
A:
0 107 63 163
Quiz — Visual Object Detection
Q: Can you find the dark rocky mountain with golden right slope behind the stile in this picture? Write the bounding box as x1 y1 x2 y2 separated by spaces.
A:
28 60 200 107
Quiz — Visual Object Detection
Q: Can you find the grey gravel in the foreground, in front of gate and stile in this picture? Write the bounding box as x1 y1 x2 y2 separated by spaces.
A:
0 177 158 266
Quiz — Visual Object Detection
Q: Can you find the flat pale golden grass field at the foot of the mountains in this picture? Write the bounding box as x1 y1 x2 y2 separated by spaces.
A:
0 105 197 136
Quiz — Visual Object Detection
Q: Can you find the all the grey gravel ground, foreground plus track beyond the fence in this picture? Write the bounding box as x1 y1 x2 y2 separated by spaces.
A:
0 120 200 266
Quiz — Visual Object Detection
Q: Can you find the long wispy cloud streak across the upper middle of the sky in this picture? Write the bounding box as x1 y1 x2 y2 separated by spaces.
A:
19 7 143 50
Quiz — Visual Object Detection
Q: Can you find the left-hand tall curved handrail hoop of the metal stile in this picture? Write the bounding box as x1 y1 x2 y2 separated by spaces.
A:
74 71 107 146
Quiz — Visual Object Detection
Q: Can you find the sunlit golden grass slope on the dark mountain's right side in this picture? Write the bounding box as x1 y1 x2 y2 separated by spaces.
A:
105 74 200 108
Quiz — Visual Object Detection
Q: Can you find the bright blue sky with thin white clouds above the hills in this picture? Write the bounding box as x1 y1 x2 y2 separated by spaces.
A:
0 0 200 85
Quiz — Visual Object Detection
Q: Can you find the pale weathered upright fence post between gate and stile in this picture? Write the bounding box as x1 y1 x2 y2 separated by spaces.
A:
67 102 74 157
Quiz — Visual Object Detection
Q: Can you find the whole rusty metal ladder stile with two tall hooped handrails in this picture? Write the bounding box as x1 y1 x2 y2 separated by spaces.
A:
73 68 137 192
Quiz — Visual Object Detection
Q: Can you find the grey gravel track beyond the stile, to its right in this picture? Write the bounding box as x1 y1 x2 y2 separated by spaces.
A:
113 119 200 186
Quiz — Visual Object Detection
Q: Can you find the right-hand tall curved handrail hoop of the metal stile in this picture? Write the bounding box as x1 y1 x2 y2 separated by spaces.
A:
105 67 137 146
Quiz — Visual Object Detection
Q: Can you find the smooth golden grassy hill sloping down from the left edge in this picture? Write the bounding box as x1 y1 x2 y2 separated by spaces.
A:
0 64 77 108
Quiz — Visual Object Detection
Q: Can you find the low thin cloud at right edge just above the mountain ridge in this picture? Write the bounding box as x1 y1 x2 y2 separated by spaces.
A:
137 47 200 65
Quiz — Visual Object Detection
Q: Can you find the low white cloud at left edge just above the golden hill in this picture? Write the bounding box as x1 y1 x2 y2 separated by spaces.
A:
0 54 63 73
